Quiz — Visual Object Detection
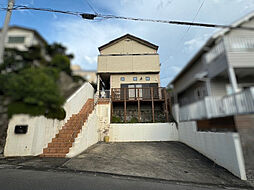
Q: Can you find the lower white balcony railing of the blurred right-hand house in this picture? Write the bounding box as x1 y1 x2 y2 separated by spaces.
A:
179 87 254 121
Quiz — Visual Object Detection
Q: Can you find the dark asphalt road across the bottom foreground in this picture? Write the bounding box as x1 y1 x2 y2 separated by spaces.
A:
0 168 250 190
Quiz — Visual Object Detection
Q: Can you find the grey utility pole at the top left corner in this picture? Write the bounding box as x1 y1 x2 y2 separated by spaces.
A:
0 0 15 64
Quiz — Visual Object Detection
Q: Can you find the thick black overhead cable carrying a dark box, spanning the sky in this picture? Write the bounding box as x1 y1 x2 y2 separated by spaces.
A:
2 6 254 31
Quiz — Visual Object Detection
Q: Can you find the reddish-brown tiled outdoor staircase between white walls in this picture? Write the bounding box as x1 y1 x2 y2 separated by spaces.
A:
40 99 94 157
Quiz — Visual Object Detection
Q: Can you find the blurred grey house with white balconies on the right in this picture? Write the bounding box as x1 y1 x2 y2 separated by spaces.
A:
169 13 254 121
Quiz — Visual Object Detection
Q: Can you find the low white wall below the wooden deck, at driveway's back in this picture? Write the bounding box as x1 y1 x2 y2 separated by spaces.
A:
109 123 178 142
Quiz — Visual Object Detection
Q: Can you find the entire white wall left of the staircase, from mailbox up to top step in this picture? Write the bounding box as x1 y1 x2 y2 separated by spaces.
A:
4 83 94 156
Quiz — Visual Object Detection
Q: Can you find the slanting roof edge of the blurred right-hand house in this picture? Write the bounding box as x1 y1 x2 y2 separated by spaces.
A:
169 12 254 84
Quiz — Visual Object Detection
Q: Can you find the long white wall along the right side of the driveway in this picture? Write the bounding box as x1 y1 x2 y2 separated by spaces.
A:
178 121 246 180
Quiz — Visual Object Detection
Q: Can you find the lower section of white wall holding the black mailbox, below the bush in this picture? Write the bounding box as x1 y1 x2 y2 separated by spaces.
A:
4 114 64 156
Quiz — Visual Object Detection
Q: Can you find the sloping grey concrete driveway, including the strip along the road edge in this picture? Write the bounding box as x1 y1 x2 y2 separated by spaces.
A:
0 142 251 189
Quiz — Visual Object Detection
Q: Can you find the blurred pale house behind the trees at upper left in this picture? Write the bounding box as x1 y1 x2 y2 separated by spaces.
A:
0 26 47 51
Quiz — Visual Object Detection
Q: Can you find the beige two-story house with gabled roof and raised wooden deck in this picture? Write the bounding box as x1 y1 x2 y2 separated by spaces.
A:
97 34 168 122
